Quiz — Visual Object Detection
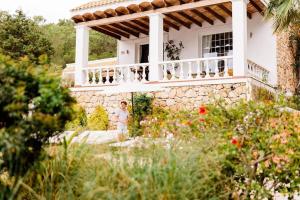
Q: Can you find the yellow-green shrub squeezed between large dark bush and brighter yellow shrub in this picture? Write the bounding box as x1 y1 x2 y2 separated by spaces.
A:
66 104 87 131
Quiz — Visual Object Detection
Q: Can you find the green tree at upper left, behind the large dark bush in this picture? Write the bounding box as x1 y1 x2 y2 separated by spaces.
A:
0 10 54 62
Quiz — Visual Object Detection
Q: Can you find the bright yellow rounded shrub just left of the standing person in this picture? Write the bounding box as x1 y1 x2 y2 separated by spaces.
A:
88 106 109 131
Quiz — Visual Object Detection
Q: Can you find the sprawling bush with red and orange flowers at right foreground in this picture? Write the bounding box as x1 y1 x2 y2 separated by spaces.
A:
143 102 300 199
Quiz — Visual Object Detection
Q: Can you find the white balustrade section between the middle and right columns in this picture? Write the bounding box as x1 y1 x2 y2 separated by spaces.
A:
159 56 232 81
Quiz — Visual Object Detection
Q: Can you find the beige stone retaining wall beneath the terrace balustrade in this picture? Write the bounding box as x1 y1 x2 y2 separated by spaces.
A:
72 82 248 126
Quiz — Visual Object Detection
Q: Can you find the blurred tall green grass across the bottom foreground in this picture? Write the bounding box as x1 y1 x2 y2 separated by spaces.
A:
19 134 230 200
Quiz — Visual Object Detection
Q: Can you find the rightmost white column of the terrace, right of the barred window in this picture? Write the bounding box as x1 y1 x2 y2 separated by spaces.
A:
232 0 248 76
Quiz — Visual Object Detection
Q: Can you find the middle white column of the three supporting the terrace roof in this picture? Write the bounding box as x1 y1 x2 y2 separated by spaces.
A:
149 13 164 81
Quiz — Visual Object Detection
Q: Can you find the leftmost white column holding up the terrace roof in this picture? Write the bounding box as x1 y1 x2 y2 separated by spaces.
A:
75 26 90 86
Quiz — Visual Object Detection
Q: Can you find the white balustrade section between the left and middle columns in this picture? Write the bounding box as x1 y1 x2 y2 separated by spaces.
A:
83 63 149 86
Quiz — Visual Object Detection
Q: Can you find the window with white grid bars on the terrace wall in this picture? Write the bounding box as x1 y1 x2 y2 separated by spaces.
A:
202 32 232 57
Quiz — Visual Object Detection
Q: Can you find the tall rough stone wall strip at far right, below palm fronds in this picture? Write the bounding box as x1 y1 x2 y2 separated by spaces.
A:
277 32 297 92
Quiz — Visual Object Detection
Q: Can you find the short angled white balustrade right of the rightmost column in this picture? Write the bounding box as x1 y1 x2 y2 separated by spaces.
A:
247 60 270 83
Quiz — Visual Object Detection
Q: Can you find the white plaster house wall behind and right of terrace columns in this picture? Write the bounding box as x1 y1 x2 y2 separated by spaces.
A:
118 13 277 85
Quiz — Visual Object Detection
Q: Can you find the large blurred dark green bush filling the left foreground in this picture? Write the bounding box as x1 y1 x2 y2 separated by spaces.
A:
0 56 74 199
